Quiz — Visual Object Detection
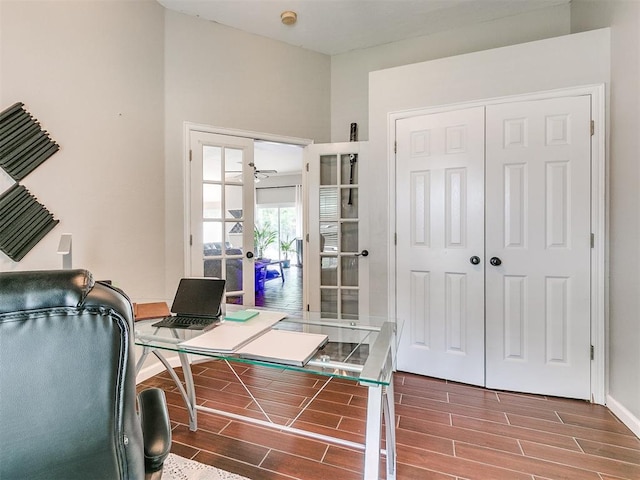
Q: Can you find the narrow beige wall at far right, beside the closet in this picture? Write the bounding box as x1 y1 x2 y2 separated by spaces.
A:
571 0 640 435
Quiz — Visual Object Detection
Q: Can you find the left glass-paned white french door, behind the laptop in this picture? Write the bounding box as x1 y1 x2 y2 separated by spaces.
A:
189 131 255 306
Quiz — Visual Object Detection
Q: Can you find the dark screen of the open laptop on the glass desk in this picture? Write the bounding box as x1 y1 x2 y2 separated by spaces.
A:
171 278 225 317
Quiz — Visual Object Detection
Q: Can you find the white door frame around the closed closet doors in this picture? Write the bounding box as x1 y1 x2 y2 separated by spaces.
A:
387 84 609 405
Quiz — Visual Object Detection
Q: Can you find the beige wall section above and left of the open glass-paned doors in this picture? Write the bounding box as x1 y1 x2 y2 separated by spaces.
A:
165 10 331 291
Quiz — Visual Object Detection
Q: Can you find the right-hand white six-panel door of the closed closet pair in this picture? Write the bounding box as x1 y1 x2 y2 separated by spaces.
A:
485 95 591 399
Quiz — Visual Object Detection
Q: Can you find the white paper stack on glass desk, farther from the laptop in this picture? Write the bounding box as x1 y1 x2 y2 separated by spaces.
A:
236 330 329 367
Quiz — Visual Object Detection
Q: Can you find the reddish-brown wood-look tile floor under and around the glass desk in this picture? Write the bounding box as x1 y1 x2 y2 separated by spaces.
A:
139 361 640 480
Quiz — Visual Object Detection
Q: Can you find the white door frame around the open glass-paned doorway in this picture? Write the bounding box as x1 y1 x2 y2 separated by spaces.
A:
182 122 314 305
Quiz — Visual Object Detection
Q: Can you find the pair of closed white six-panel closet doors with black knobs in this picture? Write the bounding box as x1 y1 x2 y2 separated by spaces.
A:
396 95 591 399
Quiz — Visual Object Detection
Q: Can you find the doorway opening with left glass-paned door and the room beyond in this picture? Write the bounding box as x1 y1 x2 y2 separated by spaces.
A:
185 122 313 314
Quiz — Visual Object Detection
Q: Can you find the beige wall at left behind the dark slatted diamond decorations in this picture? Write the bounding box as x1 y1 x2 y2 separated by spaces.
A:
0 0 165 298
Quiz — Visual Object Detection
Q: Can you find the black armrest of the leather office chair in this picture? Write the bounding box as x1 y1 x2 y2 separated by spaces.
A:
138 388 171 472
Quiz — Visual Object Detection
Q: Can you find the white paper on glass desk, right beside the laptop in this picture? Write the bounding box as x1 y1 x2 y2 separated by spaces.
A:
179 311 287 353
